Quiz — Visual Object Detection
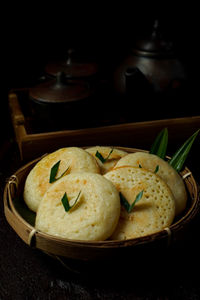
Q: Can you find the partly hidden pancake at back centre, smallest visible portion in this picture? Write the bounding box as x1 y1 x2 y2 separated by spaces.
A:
86 146 127 174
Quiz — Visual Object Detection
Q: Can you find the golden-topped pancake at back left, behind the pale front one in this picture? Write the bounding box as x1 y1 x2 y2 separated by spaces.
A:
24 147 100 212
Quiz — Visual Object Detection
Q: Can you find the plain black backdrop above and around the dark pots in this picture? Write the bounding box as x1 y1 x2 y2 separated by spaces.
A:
3 9 200 136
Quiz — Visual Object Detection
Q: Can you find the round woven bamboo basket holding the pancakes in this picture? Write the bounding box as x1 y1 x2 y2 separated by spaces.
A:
4 147 200 272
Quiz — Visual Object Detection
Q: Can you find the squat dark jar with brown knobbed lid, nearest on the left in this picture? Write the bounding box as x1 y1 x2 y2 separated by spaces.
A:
29 72 92 129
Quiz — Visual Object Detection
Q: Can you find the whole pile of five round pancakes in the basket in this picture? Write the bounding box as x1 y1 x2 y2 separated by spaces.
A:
24 146 187 241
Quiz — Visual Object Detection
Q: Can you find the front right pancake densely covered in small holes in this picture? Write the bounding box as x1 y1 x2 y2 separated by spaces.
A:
104 167 175 240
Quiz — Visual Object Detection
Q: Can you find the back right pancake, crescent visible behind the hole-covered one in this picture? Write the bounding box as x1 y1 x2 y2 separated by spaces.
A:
116 152 187 215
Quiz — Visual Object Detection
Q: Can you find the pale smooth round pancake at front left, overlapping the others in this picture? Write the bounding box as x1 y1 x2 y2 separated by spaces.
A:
35 172 120 240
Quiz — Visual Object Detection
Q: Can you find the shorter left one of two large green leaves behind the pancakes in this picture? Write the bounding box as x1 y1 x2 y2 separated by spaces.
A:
149 128 168 159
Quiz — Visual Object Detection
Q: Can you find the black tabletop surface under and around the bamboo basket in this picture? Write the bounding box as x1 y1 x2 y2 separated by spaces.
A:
0 136 200 300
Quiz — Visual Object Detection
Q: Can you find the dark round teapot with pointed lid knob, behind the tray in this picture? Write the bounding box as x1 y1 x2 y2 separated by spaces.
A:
113 21 188 119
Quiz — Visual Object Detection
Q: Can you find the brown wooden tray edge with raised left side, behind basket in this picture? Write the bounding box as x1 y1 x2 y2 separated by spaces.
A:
9 93 200 161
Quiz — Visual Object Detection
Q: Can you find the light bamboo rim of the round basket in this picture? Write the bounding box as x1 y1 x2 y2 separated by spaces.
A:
4 146 200 248
